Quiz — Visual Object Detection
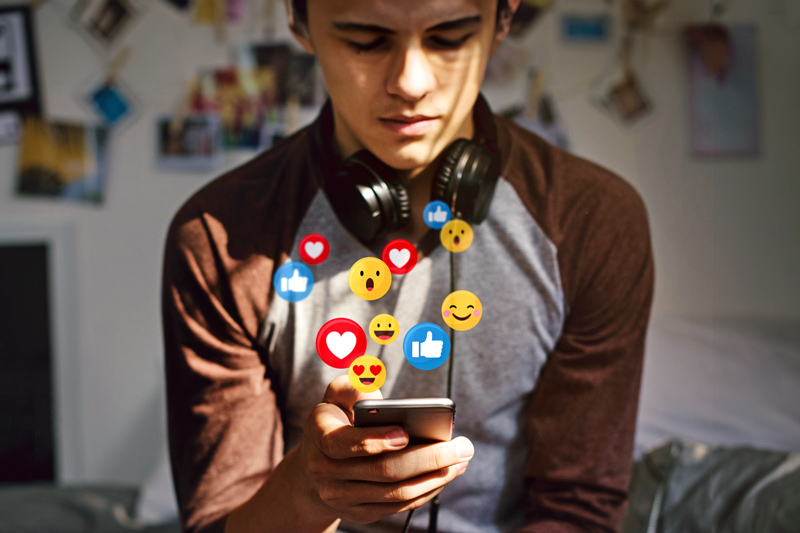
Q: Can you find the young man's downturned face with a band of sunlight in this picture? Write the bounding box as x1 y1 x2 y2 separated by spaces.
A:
299 0 510 172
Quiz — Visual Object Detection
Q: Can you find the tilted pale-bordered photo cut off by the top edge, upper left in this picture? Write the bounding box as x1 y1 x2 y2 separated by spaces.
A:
71 0 141 50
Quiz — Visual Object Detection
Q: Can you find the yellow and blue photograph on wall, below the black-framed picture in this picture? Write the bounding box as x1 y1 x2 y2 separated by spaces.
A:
17 116 108 204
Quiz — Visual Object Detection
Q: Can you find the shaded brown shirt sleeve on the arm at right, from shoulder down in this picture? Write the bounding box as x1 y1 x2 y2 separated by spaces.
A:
523 166 653 533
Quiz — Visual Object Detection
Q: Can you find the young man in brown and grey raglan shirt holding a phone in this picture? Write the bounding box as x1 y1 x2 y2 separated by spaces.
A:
163 0 653 532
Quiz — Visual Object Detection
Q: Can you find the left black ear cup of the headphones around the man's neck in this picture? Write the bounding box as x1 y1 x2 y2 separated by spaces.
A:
325 150 411 242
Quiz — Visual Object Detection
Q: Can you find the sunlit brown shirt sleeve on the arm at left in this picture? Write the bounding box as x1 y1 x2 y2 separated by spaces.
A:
162 209 283 532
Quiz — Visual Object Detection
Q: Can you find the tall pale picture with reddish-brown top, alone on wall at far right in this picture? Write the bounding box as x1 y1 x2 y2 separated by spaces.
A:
686 24 760 157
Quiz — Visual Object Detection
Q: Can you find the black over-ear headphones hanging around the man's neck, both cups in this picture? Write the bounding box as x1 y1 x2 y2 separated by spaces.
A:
325 139 500 242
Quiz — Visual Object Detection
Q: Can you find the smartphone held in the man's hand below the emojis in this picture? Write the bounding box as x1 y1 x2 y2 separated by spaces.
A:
353 398 456 444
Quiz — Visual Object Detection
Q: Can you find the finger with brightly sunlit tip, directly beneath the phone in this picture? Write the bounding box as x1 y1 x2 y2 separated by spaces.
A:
330 436 475 483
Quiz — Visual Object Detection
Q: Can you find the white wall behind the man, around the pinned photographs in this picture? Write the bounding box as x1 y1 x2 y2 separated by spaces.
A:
0 0 800 483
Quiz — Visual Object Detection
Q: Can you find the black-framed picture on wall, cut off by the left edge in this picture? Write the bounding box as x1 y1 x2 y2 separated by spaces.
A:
0 5 42 144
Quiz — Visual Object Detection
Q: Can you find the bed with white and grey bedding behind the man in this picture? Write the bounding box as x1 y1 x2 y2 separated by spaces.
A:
0 318 800 533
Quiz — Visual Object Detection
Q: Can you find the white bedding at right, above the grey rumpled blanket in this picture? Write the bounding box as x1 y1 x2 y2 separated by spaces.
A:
636 319 800 458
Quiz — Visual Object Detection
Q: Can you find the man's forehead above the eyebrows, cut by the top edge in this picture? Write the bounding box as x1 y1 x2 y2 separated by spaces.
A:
308 0 497 30
